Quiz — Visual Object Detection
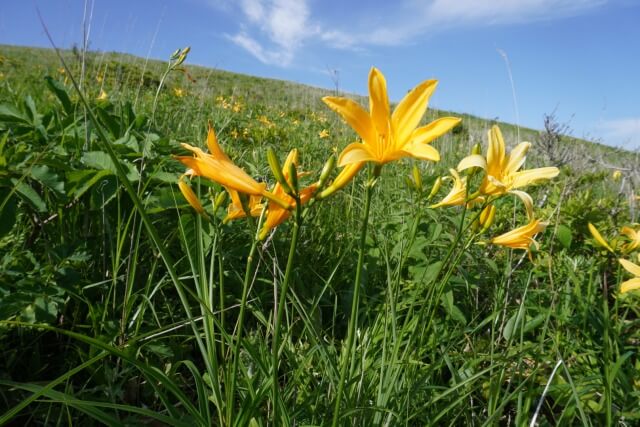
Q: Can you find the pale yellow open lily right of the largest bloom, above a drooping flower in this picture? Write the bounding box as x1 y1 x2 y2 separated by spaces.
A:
458 125 560 196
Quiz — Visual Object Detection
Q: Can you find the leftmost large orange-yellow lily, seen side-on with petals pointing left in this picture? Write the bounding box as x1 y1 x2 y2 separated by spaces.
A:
176 126 288 206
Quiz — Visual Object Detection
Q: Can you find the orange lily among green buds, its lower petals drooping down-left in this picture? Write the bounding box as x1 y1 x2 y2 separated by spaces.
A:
258 149 317 240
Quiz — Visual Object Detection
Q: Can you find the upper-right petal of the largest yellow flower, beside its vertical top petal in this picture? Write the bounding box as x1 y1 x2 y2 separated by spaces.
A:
391 80 438 145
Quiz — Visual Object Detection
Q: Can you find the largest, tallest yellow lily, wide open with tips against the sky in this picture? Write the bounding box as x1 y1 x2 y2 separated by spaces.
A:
322 68 460 166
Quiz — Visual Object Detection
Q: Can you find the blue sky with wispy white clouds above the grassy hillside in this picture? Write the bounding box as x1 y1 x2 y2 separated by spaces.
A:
0 0 640 149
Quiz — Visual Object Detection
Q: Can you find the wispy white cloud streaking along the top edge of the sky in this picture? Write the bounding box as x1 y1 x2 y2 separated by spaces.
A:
220 0 607 66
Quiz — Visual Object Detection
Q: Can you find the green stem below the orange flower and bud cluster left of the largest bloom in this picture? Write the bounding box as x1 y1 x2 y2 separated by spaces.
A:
271 198 302 426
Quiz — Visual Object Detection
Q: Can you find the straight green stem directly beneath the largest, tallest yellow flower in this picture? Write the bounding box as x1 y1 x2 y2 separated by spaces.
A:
331 166 380 427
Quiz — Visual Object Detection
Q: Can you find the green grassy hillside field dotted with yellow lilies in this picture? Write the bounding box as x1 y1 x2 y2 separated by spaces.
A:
0 46 640 426
